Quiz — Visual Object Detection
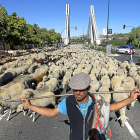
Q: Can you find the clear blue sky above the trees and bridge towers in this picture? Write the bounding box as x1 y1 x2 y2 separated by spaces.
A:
0 0 140 37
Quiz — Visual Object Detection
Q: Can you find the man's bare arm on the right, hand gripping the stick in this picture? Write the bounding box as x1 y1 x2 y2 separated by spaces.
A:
110 88 140 111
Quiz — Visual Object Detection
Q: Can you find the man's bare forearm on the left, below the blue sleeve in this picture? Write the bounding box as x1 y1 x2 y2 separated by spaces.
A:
20 97 61 117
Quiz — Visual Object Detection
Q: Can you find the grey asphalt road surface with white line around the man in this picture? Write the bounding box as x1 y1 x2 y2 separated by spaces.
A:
0 51 140 140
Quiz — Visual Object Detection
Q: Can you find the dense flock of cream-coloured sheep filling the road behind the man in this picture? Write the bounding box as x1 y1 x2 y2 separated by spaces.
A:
0 45 140 127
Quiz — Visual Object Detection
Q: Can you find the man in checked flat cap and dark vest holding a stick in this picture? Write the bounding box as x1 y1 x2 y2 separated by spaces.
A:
20 72 140 140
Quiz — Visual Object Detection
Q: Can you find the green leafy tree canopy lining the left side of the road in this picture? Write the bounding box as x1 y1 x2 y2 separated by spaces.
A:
0 5 60 47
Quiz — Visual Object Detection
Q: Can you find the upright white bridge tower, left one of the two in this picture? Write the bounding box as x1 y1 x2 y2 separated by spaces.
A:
64 4 70 45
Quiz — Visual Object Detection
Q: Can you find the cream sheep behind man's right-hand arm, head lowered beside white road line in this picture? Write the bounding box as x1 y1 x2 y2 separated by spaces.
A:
113 87 128 127
